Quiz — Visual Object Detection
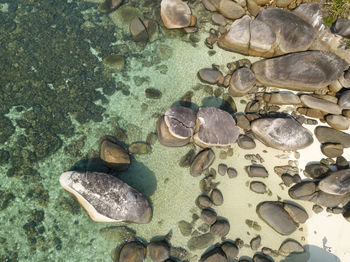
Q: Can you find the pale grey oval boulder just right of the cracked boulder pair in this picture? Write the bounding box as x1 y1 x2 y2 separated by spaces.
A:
251 118 313 151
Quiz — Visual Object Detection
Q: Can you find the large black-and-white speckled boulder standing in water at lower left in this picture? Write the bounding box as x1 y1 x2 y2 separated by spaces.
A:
60 171 152 224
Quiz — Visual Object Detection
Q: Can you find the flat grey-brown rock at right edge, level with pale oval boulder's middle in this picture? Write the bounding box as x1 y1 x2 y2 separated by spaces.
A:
315 126 350 148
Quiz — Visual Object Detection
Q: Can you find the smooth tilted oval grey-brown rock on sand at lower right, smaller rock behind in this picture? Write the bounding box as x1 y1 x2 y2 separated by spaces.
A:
256 201 298 235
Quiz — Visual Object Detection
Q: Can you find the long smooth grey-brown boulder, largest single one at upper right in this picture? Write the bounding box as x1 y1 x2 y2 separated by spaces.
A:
252 51 346 92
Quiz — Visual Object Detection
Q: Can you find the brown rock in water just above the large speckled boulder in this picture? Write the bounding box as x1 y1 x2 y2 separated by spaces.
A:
100 139 130 171
